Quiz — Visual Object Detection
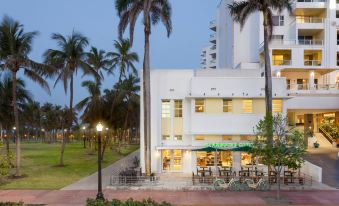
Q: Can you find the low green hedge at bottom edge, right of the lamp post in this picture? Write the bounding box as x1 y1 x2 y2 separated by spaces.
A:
86 198 171 206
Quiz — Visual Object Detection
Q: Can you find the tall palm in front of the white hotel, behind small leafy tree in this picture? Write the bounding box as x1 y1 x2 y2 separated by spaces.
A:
228 0 292 142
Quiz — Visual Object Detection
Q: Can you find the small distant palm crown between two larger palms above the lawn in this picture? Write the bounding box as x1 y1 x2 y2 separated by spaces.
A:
86 47 109 79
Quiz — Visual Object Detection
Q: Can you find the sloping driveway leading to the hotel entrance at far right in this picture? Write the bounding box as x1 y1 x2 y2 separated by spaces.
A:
306 133 339 188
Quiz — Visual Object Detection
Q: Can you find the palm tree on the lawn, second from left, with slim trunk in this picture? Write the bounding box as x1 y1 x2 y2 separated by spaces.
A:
44 31 100 166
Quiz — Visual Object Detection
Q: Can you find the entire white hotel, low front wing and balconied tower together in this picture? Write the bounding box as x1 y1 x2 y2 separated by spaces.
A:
140 0 339 174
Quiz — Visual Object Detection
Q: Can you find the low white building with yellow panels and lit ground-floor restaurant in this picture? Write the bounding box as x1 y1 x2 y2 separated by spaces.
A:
140 69 289 174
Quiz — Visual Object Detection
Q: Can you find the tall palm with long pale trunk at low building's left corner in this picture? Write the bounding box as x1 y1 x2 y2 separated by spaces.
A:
115 0 172 175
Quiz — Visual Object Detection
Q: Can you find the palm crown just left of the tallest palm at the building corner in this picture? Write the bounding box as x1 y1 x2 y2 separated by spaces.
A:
107 39 139 84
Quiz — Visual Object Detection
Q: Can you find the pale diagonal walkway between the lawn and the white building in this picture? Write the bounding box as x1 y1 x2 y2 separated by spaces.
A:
61 150 140 190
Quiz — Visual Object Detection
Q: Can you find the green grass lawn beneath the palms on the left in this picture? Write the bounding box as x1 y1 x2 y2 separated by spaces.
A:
0 142 139 189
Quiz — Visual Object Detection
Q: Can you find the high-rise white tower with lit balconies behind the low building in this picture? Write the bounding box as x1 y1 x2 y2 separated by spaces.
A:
202 0 339 136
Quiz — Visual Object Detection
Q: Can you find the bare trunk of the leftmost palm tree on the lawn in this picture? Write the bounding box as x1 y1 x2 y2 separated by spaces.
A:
12 69 21 177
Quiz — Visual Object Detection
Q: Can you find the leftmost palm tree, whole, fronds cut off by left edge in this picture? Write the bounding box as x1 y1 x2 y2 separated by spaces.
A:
0 16 52 176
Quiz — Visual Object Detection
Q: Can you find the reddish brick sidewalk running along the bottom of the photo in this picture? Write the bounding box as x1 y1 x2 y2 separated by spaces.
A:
0 190 339 206
